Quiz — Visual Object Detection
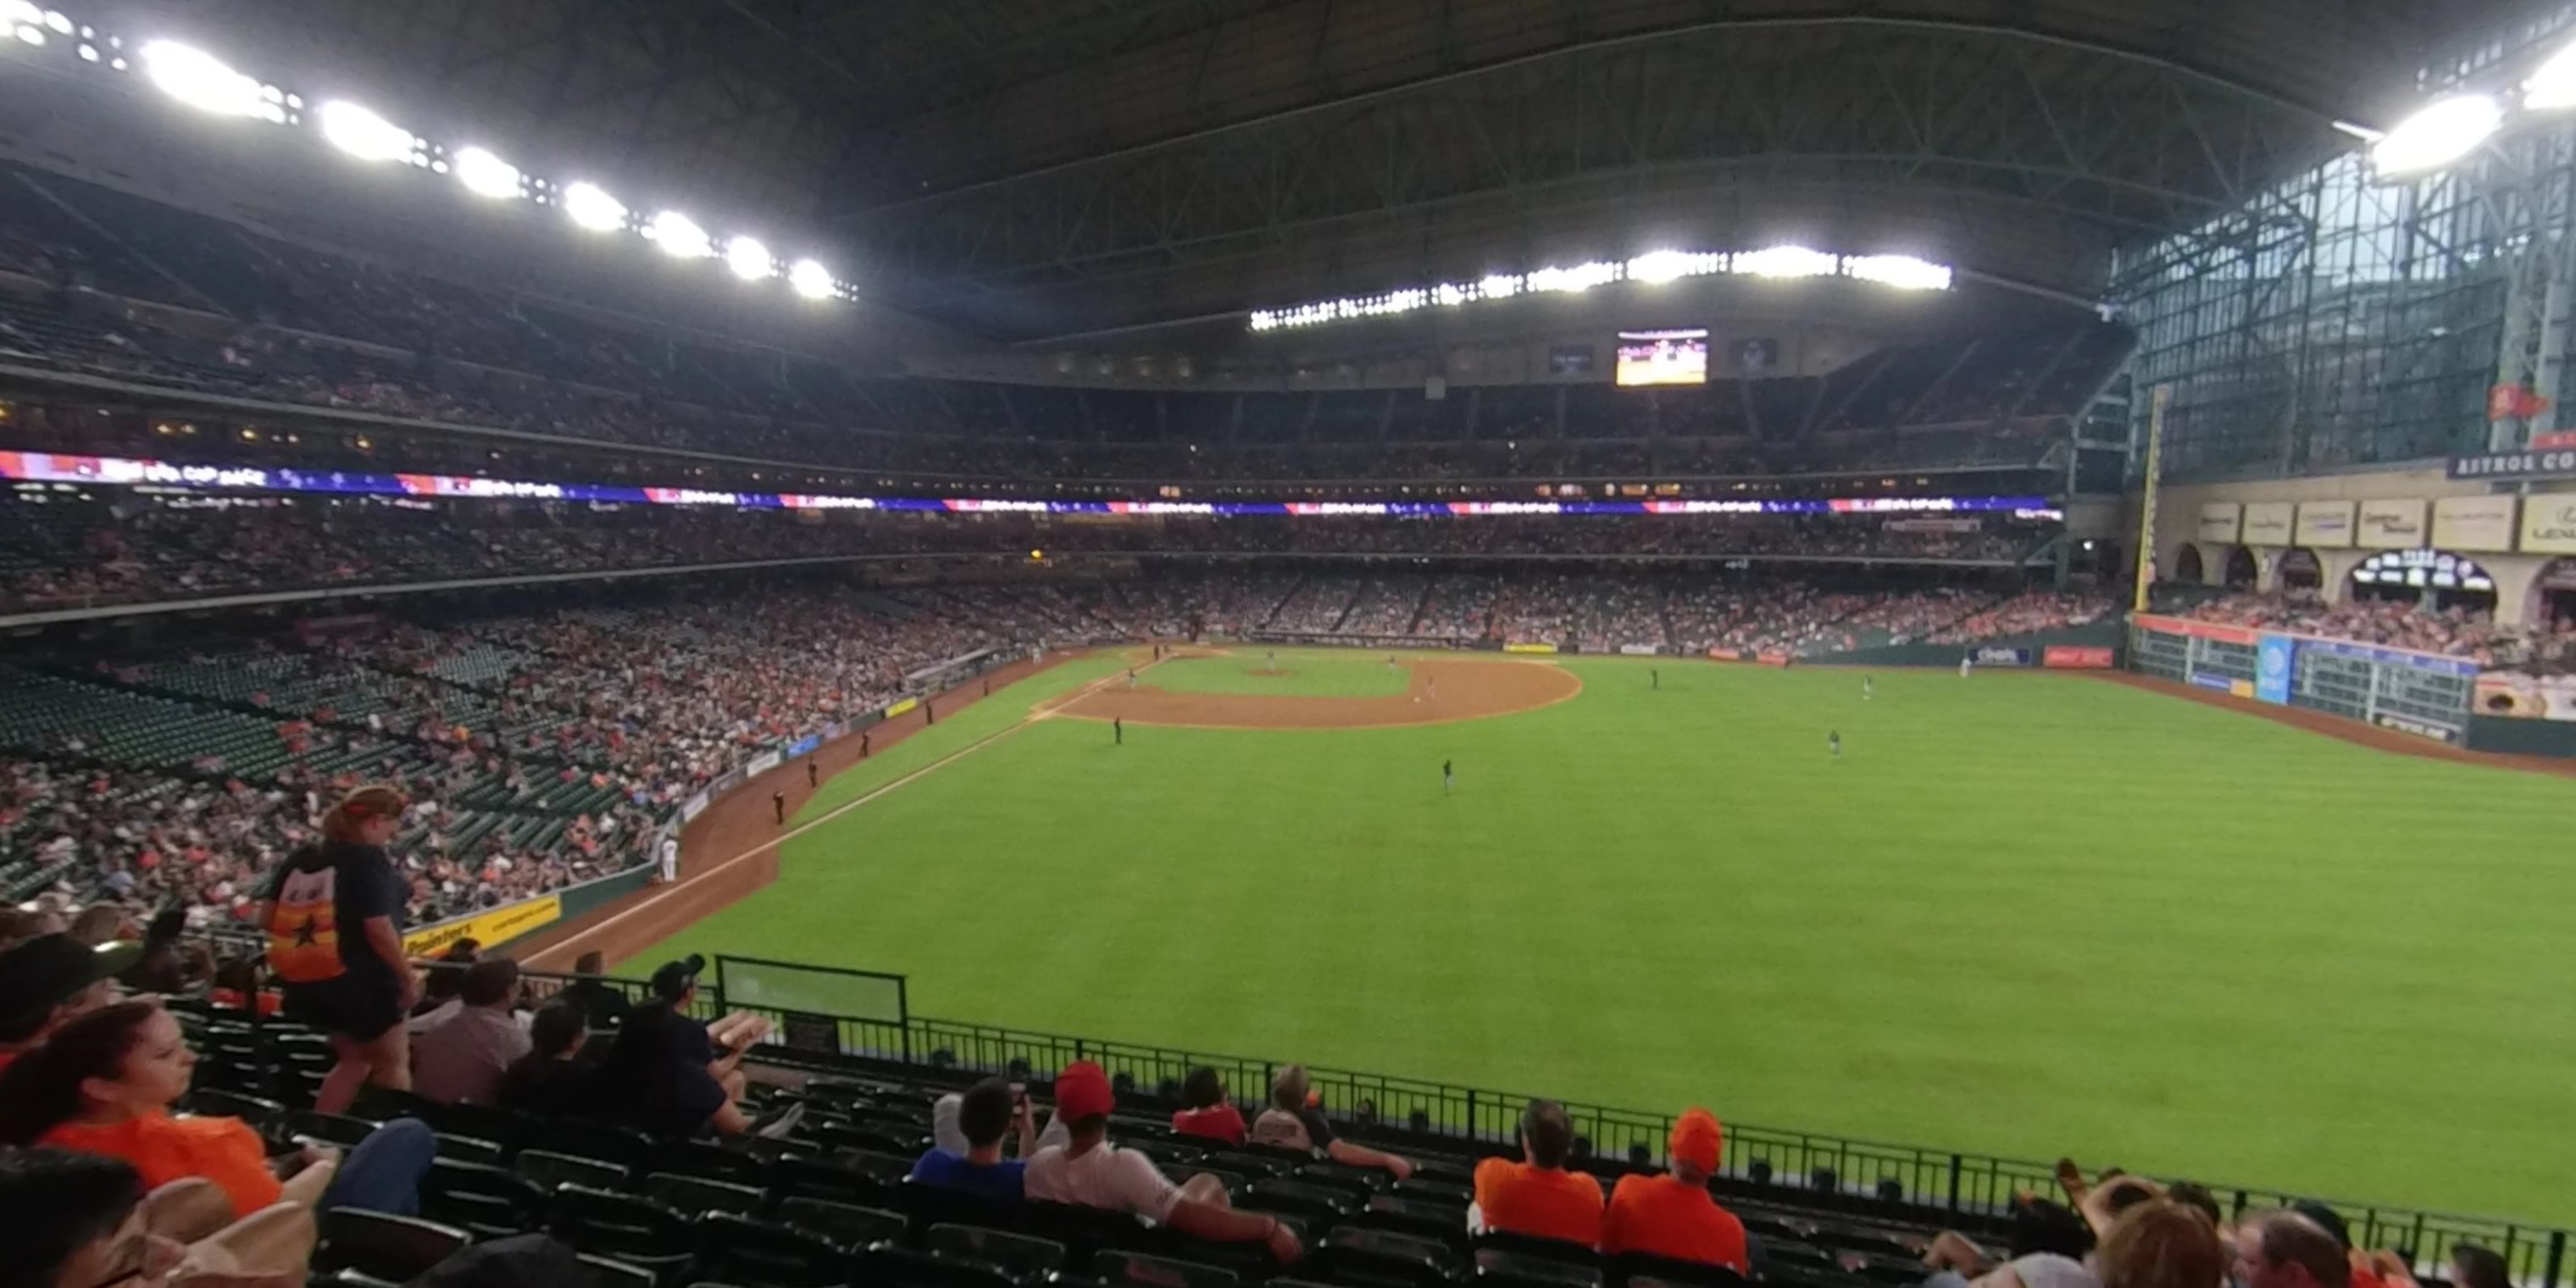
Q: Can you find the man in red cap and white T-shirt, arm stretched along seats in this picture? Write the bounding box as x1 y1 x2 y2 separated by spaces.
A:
1023 1058 1306 1263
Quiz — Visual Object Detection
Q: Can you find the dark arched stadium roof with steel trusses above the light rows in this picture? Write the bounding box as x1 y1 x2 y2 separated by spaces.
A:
176 0 2507 340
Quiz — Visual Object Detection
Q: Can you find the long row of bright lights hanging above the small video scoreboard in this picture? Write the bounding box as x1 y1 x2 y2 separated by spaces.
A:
1252 245 1955 330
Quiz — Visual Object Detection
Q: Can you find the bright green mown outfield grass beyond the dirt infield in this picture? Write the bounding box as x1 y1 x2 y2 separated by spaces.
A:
641 652 2576 1221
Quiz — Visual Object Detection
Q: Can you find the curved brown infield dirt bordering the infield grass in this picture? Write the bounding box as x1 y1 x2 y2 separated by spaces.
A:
1061 657 1585 729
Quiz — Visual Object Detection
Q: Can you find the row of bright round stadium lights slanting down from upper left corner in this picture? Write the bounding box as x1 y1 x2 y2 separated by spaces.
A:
0 0 858 302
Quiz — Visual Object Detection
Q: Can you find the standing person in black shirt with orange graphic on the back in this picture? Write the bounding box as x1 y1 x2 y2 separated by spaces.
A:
260 786 420 1113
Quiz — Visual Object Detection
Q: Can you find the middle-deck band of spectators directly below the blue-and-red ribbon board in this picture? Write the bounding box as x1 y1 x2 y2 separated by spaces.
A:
0 495 2048 610
